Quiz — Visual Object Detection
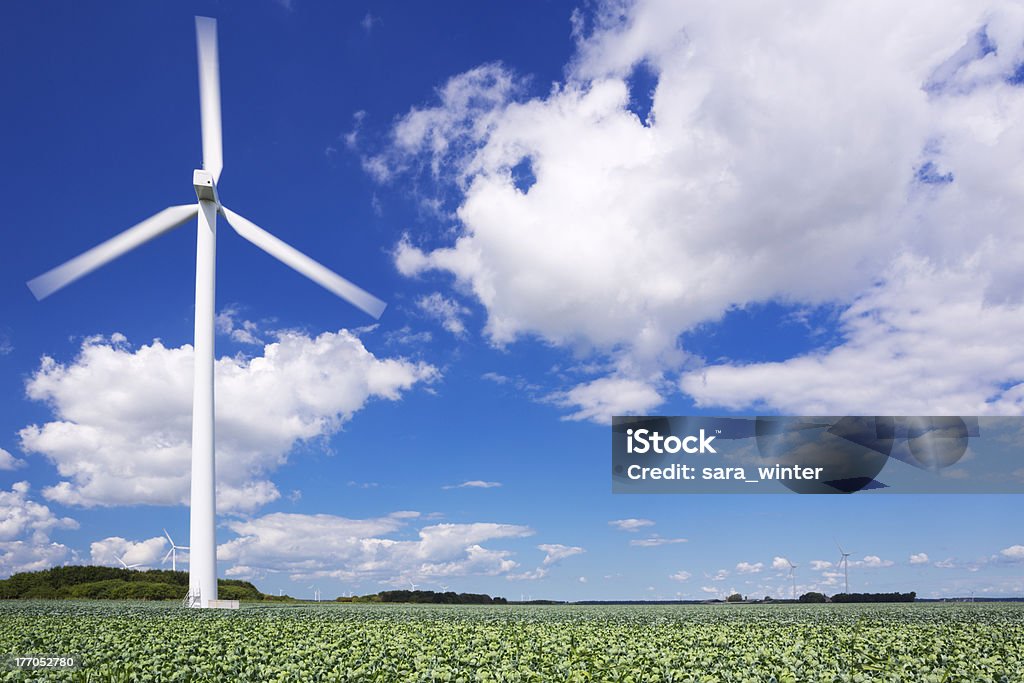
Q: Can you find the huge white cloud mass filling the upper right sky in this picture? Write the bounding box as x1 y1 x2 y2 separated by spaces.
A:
378 0 1024 422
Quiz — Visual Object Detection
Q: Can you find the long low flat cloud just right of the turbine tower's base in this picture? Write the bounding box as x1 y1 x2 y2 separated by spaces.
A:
217 511 532 585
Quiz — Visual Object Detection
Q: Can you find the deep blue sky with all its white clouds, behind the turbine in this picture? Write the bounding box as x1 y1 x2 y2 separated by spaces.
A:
0 0 1024 599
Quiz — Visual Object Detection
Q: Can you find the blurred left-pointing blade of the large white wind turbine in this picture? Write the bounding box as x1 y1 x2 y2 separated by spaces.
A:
28 204 199 299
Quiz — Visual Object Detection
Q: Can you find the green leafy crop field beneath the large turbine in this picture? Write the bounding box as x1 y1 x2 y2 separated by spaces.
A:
0 601 1024 683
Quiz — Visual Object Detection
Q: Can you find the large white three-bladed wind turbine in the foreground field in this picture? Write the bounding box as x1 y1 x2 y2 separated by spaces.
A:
28 16 386 607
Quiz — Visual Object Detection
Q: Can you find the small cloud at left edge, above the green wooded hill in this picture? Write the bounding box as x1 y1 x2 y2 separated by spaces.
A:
0 481 78 577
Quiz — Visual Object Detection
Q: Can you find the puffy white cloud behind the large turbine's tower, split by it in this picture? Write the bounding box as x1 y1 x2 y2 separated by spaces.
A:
20 330 438 512
